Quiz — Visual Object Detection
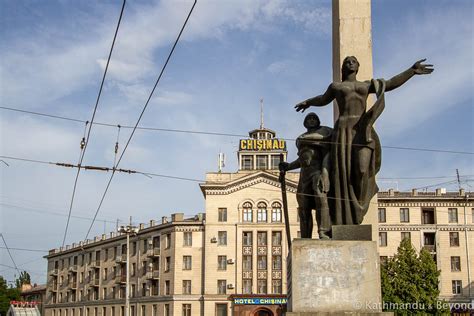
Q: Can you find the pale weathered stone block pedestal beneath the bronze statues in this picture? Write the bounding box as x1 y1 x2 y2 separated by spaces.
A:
287 239 385 316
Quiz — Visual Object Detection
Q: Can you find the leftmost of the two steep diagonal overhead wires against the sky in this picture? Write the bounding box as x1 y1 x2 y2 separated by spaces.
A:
62 0 127 247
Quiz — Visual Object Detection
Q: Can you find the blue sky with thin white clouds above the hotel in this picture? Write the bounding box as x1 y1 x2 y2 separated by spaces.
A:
0 0 474 283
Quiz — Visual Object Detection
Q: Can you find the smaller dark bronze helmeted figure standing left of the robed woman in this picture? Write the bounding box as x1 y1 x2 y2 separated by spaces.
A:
279 113 332 239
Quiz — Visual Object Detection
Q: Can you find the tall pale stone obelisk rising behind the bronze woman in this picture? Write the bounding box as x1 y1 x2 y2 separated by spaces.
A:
332 0 378 240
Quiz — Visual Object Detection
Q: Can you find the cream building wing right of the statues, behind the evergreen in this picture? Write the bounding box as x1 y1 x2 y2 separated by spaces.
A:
378 189 474 303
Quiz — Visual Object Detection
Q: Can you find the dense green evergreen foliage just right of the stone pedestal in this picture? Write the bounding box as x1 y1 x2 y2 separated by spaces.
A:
381 239 446 315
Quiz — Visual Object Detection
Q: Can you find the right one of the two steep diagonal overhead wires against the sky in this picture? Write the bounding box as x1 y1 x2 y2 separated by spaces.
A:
84 0 197 239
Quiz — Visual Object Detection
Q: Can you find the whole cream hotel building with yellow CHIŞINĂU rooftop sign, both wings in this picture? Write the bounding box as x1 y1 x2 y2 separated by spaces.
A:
45 126 474 316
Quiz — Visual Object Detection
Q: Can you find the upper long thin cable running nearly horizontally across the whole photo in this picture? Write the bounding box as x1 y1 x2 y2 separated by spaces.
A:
0 106 474 155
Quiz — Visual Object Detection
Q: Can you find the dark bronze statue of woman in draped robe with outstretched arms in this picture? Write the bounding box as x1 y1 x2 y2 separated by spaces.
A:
295 56 433 225
